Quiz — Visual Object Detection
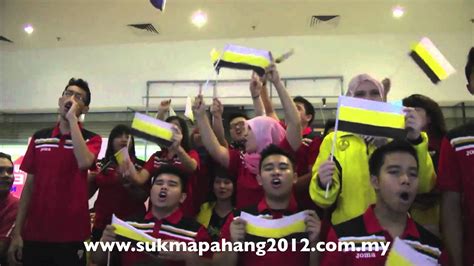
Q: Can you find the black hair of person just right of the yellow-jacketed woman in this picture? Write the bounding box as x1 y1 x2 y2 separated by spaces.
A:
403 94 447 138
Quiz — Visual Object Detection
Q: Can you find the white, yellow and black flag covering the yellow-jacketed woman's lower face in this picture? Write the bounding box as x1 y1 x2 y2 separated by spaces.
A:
336 96 406 139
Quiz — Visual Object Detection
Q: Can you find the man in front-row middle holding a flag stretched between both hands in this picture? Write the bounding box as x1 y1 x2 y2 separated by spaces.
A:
214 145 321 266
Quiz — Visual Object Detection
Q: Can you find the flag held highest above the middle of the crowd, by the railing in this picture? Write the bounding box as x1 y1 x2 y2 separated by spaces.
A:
211 44 271 76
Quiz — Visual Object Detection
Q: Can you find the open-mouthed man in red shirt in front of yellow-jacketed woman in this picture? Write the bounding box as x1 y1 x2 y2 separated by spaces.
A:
321 141 441 266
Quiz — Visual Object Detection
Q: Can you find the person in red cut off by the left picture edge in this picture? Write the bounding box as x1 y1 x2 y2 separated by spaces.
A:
0 152 18 265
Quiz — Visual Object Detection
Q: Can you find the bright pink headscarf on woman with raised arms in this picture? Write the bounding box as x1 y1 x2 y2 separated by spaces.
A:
244 116 286 175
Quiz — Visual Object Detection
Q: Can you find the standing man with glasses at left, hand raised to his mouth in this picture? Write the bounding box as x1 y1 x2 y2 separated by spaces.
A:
9 78 102 266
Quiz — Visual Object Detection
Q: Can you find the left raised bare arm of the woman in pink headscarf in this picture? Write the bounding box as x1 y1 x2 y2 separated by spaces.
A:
193 95 229 168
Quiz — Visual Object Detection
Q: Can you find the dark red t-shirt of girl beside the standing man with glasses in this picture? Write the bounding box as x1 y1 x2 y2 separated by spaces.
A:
94 160 150 230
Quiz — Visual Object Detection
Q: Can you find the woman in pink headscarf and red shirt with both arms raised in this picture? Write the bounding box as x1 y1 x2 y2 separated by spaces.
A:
193 64 301 208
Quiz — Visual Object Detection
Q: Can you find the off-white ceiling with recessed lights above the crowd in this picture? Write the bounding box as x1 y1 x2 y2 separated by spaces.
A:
0 0 474 50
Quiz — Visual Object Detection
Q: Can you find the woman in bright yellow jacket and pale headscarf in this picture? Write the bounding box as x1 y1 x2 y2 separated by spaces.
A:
309 74 436 225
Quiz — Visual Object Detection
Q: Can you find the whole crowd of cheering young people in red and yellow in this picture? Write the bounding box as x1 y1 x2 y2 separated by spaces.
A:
0 48 474 265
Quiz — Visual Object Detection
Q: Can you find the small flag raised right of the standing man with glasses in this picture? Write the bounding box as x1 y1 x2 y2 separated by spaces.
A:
132 113 173 146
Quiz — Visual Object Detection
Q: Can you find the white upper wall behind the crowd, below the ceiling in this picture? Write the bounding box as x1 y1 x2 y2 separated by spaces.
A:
0 30 473 111
